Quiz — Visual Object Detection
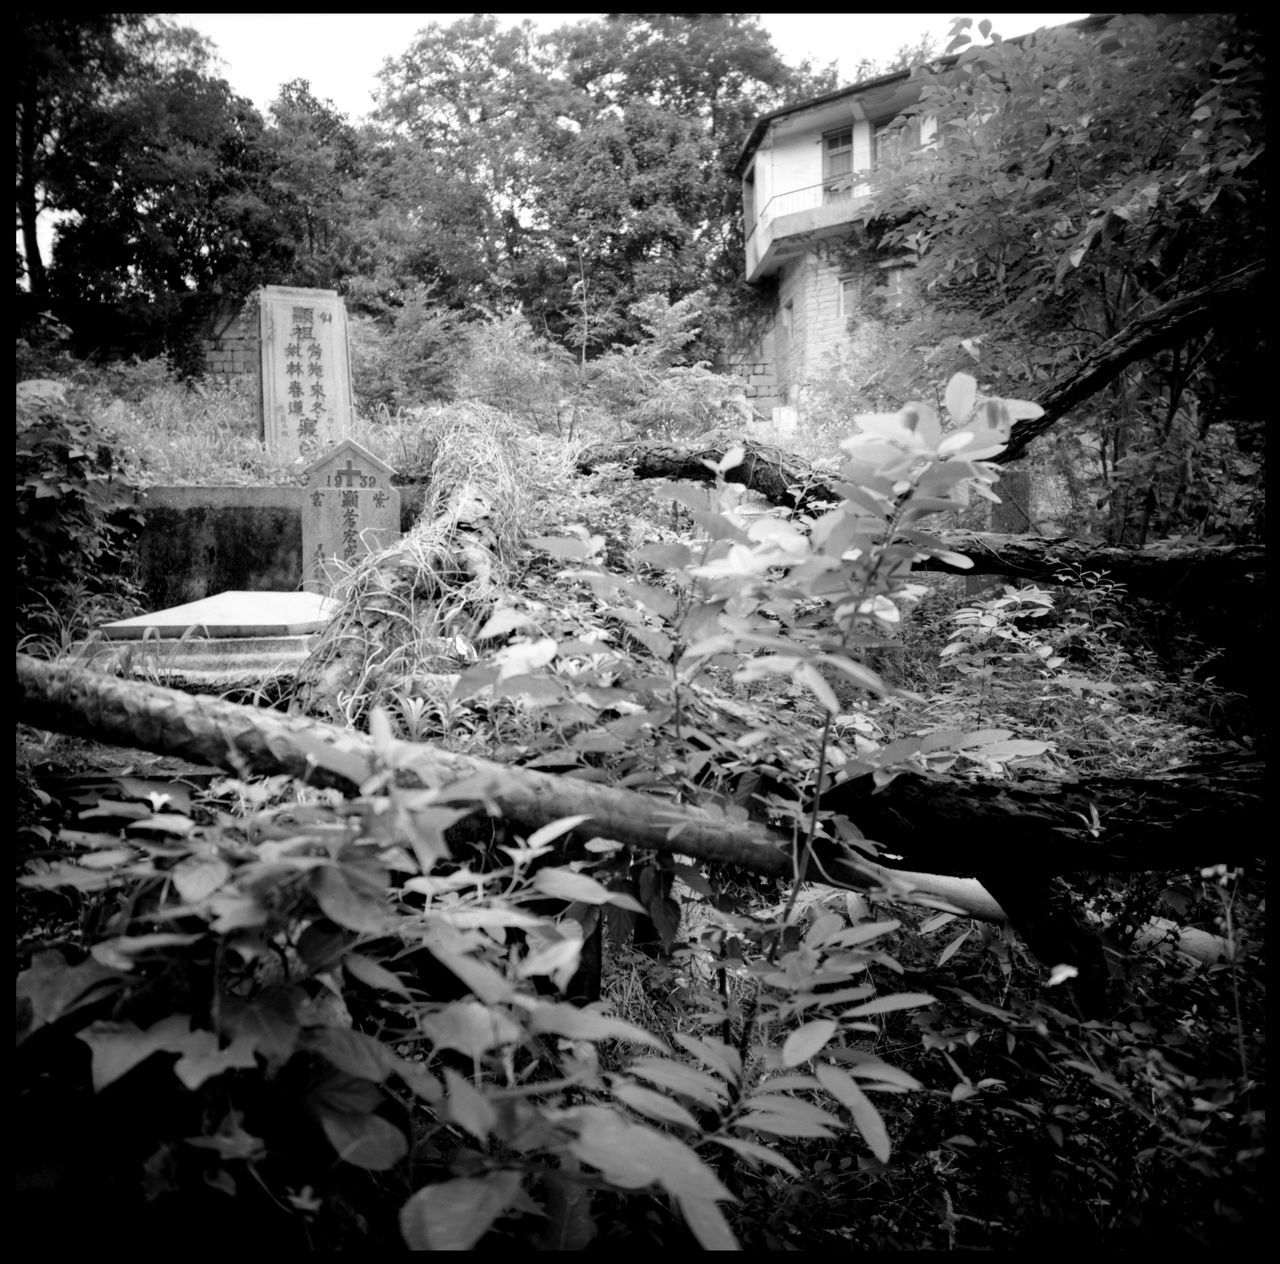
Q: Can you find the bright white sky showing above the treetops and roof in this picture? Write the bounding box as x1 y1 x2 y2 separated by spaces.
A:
169 12 1084 122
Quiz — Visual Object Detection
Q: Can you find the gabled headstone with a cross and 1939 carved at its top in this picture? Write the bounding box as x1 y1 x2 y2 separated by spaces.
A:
302 439 399 592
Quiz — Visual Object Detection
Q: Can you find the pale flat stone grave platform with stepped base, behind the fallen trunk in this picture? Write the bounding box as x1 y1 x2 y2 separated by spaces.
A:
74 592 335 693
